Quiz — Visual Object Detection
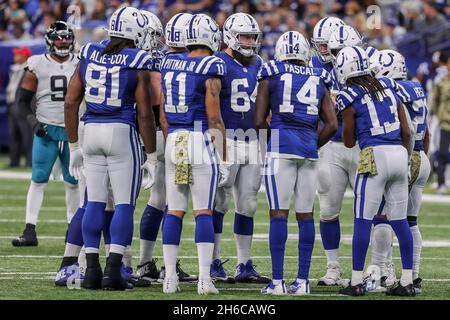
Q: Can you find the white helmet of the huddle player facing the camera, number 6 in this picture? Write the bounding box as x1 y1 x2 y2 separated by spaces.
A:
223 12 261 57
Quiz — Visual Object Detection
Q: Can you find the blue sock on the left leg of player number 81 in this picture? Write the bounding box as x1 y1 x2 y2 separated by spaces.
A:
81 201 106 249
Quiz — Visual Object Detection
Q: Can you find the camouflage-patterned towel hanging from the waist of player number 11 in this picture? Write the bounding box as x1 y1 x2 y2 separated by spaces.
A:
175 131 192 184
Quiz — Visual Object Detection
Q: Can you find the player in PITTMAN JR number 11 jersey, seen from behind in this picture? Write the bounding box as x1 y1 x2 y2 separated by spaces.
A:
160 14 226 294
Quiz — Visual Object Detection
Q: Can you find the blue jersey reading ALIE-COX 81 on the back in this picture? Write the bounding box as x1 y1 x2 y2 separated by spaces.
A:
79 43 153 126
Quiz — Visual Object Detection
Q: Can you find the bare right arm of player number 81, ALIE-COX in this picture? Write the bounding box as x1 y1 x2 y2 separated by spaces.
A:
135 71 156 153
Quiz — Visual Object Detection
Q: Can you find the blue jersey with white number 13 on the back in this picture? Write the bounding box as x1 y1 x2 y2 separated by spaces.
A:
336 77 402 149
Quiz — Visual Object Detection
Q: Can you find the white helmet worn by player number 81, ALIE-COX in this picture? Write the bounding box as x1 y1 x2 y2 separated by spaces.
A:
108 7 147 49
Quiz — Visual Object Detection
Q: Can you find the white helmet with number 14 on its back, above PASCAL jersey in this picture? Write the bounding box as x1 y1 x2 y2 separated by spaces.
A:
275 31 310 64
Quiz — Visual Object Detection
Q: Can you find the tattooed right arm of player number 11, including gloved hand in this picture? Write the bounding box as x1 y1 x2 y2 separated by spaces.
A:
205 78 226 161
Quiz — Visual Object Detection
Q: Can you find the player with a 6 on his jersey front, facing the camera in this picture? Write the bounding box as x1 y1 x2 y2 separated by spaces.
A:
211 13 270 283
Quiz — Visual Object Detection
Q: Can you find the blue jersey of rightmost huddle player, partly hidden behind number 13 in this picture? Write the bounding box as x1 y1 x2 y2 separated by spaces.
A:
397 80 428 151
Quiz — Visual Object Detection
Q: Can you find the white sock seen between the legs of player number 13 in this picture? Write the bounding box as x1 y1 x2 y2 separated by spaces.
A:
371 223 393 270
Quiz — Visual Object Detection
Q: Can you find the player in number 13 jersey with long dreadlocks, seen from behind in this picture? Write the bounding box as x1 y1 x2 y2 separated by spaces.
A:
336 47 415 296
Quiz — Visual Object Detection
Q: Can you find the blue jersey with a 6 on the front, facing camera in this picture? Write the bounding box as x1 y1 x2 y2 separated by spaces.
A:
217 51 263 138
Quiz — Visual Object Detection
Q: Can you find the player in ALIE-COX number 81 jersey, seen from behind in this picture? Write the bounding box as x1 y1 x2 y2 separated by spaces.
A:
65 7 156 290
